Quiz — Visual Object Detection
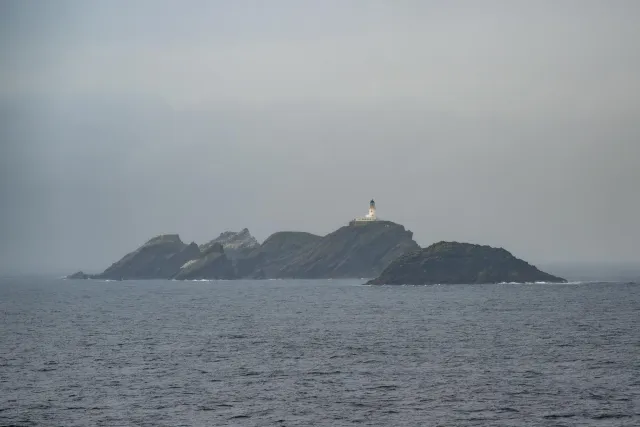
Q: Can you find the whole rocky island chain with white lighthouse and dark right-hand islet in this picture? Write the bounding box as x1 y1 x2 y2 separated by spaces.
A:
67 200 565 284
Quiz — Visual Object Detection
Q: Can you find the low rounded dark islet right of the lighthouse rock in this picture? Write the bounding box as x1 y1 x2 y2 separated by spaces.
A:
367 242 566 285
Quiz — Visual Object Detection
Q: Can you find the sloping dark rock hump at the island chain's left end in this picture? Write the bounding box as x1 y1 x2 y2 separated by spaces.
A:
92 234 201 280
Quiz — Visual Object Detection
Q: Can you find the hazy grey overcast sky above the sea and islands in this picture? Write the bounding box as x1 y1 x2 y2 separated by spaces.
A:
0 0 640 272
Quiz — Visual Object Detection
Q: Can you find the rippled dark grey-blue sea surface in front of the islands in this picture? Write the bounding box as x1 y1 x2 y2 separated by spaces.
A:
0 278 640 426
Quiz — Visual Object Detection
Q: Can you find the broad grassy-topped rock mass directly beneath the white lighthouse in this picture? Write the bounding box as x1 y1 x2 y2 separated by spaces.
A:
238 221 419 279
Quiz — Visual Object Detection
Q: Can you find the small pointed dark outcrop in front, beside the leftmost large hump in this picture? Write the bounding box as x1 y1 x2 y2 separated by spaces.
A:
174 243 236 280
